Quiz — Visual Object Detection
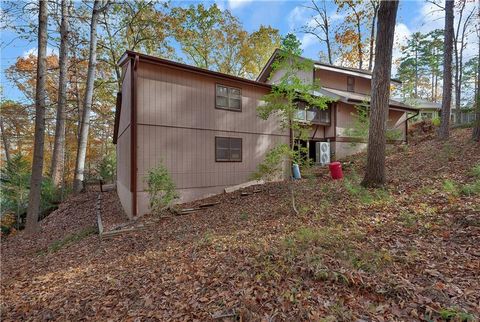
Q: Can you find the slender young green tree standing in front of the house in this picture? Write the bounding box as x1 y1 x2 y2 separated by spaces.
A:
257 38 332 214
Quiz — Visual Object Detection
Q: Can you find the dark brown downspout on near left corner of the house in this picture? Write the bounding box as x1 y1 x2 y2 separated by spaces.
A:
130 55 140 217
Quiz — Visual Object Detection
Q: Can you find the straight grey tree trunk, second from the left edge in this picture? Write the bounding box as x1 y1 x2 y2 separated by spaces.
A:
50 0 69 187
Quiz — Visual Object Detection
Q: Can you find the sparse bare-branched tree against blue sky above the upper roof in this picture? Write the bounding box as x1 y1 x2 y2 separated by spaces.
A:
302 0 333 65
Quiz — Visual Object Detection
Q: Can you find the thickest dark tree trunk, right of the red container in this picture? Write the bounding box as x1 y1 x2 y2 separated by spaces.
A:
362 0 398 187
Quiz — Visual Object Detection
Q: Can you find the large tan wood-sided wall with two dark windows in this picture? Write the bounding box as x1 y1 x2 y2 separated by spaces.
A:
136 61 288 214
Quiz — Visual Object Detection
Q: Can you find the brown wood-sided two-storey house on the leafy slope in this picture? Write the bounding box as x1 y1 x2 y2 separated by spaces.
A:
113 51 414 217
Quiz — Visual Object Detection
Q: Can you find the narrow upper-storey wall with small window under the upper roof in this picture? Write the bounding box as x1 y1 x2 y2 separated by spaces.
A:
315 68 371 95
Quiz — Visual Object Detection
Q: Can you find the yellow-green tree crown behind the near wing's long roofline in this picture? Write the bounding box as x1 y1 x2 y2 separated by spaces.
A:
170 3 280 78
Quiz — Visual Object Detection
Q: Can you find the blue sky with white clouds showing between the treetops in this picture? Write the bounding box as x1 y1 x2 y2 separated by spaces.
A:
0 0 476 100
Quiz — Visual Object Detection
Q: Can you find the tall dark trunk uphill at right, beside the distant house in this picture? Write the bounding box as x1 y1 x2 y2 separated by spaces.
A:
438 0 454 140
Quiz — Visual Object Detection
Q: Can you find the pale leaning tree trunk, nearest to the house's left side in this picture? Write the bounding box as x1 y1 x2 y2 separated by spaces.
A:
73 0 102 193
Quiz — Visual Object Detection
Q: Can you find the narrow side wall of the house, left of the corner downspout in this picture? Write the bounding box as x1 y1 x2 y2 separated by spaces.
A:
116 62 132 217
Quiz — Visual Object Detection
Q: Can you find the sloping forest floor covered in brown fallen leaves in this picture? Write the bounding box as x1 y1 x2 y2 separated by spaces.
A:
1 130 480 321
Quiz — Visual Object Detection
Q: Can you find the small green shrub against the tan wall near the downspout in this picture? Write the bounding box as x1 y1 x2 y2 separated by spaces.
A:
145 162 178 213
